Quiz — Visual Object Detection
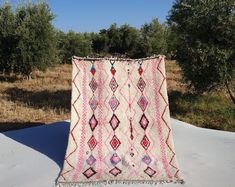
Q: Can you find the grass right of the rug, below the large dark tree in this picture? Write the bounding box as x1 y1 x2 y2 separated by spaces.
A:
166 61 235 132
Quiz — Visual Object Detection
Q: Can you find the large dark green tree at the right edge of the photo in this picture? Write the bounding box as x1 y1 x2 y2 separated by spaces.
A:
168 0 235 95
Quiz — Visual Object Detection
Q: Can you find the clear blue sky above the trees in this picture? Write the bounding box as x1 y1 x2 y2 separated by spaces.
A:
6 0 174 32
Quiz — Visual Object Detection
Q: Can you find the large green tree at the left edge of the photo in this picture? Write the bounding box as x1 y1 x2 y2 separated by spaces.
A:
0 2 57 76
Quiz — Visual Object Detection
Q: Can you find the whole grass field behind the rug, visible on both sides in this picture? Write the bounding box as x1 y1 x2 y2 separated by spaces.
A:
0 61 235 131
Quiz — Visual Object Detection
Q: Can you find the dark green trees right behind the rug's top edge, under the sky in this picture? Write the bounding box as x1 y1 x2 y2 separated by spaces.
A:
92 19 168 58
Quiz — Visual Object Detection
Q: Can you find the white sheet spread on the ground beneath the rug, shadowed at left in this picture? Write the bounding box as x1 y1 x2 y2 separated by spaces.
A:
0 119 235 187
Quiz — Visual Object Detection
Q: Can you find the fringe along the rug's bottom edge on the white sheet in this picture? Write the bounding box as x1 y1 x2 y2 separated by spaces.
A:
54 179 185 187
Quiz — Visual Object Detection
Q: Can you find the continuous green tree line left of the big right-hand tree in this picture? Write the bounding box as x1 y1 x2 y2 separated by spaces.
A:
0 1 169 68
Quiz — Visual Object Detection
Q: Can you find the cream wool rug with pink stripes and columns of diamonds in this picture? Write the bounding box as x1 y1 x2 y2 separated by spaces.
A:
57 56 182 186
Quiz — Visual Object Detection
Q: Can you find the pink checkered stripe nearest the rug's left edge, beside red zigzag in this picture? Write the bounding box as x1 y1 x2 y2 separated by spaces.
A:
73 62 88 181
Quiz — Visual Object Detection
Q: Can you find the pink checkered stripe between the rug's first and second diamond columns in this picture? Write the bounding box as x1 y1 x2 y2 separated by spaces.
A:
96 61 104 179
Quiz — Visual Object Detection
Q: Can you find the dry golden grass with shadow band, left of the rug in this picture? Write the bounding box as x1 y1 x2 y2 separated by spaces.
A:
0 65 72 131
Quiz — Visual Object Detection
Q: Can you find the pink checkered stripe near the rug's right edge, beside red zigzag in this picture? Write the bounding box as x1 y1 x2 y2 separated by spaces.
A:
151 59 172 179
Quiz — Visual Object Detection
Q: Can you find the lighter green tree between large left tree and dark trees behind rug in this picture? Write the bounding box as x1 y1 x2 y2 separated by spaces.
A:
57 31 92 63
